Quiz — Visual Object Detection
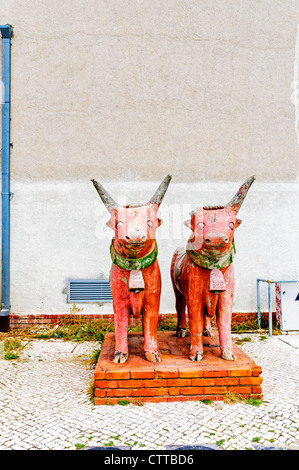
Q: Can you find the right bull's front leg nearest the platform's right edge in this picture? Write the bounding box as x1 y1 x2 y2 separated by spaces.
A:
216 292 236 361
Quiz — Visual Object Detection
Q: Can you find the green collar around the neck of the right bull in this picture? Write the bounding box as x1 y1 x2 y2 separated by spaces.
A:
186 238 236 269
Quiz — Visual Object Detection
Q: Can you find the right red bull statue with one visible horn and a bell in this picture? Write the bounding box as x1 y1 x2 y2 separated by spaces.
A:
171 176 255 361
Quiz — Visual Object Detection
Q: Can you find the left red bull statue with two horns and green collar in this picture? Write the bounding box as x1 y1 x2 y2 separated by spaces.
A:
92 175 171 363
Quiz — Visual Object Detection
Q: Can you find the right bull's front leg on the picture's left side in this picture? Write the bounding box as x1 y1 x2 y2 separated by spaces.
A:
188 302 204 362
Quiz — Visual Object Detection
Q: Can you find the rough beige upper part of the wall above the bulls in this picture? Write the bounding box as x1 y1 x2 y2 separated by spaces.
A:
0 0 299 182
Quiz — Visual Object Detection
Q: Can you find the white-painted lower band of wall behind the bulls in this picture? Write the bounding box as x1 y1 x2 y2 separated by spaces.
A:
11 180 299 313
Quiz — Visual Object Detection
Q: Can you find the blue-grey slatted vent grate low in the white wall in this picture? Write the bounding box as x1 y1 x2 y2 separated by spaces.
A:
68 279 112 303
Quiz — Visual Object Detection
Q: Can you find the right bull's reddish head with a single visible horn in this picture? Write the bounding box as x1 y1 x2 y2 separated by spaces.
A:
185 176 255 258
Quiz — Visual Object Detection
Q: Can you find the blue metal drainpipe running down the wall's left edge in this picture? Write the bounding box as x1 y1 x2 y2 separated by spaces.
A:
0 25 12 331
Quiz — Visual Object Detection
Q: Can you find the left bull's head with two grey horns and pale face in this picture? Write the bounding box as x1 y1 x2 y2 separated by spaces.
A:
91 175 171 257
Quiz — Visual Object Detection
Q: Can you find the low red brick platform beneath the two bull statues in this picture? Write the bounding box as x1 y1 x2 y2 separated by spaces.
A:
94 331 263 405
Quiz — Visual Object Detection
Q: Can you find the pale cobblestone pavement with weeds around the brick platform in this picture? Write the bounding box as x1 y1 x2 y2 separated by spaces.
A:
0 333 299 450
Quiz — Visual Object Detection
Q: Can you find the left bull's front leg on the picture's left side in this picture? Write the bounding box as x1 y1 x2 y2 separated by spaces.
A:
113 307 129 364
